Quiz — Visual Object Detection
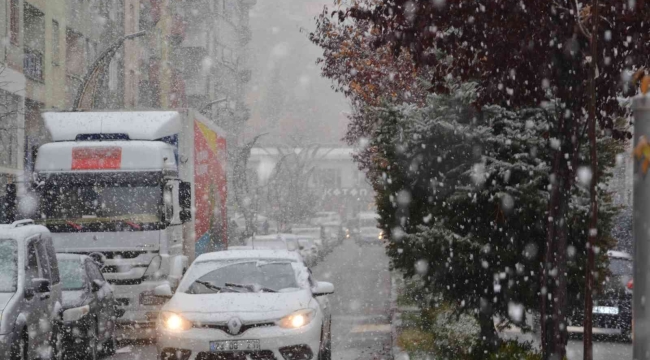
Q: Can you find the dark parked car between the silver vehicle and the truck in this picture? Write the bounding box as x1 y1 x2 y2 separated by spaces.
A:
56 254 124 359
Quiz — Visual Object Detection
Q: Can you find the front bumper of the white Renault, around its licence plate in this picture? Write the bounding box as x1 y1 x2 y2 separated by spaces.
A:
156 321 321 360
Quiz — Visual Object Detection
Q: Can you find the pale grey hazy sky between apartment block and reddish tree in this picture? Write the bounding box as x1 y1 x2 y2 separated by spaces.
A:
245 0 349 144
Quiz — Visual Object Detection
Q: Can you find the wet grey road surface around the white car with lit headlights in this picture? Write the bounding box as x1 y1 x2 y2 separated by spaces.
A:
109 240 391 360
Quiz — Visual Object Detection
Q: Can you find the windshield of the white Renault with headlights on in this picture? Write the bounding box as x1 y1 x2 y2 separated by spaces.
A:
183 261 299 294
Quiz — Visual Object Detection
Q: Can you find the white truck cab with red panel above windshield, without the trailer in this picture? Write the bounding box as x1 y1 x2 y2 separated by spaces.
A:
23 112 197 336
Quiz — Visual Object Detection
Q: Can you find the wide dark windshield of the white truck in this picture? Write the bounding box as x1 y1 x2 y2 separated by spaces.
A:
41 184 163 224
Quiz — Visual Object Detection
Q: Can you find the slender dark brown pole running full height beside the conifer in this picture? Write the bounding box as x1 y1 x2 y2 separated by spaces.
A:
583 0 600 360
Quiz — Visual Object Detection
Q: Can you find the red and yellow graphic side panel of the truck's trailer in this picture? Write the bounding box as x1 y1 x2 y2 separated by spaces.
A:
194 121 228 256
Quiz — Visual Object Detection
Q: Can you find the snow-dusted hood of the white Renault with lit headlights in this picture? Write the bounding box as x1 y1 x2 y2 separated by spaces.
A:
163 290 312 322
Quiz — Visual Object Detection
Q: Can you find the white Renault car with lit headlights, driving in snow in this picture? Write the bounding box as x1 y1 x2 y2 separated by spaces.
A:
154 250 334 360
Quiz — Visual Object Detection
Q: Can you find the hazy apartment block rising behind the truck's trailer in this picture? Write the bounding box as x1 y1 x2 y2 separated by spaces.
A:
125 0 255 139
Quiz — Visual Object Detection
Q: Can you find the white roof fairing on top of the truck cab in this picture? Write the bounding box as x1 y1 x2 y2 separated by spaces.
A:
42 111 181 141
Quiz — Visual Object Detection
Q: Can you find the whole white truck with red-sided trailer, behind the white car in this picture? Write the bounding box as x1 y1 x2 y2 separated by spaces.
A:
12 110 228 335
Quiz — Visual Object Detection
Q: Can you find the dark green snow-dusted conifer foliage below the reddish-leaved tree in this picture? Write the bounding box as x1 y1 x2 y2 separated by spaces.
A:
367 84 621 346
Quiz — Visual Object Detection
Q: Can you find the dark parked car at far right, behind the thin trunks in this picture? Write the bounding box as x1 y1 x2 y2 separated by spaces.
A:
568 251 632 337
